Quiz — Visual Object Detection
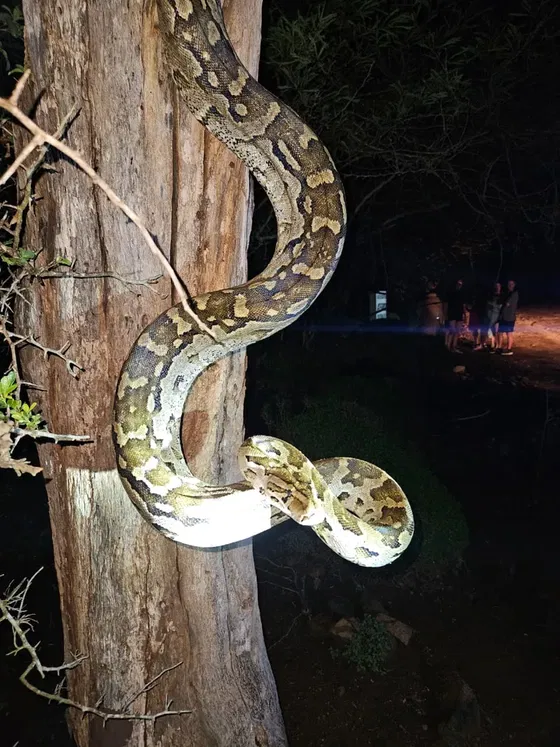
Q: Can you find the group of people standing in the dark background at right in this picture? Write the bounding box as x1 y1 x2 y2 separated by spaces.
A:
418 279 519 355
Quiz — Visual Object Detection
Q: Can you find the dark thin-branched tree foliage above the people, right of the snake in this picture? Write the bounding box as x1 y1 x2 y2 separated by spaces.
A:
257 0 560 300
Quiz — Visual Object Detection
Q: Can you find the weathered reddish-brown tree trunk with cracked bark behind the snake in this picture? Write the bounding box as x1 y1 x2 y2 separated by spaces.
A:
19 0 286 747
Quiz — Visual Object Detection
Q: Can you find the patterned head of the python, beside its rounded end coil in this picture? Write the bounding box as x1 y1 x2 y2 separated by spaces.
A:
239 436 325 526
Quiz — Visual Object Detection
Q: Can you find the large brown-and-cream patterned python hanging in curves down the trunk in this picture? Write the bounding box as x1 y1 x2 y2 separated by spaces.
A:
113 0 414 566
